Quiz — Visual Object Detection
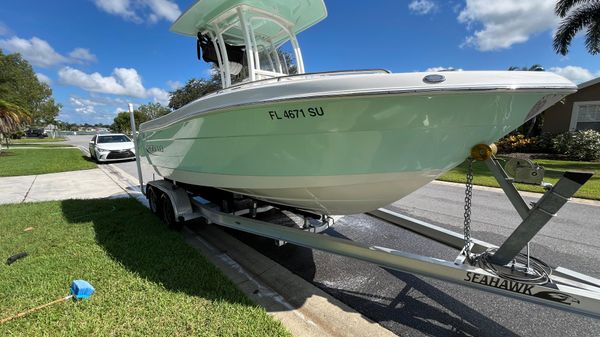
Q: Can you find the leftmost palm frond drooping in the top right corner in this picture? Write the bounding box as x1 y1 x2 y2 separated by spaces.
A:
552 3 600 55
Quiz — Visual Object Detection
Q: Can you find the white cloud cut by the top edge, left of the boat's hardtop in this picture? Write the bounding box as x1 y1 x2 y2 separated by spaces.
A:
94 0 181 23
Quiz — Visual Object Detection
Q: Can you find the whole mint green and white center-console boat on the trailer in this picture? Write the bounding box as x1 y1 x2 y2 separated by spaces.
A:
138 0 576 215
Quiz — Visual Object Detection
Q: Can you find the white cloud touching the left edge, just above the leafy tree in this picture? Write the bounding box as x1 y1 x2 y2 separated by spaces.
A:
0 36 68 67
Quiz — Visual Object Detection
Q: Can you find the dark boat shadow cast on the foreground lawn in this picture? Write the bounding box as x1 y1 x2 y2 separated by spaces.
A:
61 199 254 305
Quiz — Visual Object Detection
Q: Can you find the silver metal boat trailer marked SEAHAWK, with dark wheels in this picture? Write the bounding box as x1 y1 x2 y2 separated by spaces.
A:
130 108 600 318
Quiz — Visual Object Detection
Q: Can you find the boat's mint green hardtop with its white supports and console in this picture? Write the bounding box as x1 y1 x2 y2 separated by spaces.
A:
171 0 327 88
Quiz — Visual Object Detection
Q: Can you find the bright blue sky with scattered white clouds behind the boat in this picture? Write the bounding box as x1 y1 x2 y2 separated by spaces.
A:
0 0 600 124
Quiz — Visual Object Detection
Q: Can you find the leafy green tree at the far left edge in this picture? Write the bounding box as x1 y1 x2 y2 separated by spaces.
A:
0 50 61 124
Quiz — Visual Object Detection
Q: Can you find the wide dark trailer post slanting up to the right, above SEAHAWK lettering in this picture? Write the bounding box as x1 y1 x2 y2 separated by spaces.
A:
492 172 592 265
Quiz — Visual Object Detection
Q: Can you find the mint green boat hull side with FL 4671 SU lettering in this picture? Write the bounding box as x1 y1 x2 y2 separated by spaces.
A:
139 91 556 214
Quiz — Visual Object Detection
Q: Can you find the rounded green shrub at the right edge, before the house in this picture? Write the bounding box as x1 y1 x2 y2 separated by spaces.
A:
552 130 600 160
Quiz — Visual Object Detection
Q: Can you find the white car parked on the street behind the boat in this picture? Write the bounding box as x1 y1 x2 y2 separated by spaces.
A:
90 133 135 162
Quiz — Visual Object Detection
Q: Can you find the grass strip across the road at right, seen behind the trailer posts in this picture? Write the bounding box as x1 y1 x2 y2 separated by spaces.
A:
438 159 600 200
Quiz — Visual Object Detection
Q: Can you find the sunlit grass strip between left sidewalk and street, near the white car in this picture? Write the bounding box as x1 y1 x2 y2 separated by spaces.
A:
0 148 96 177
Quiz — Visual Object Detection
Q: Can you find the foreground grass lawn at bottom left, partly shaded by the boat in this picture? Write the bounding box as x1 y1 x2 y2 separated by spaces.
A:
0 199 290 336
